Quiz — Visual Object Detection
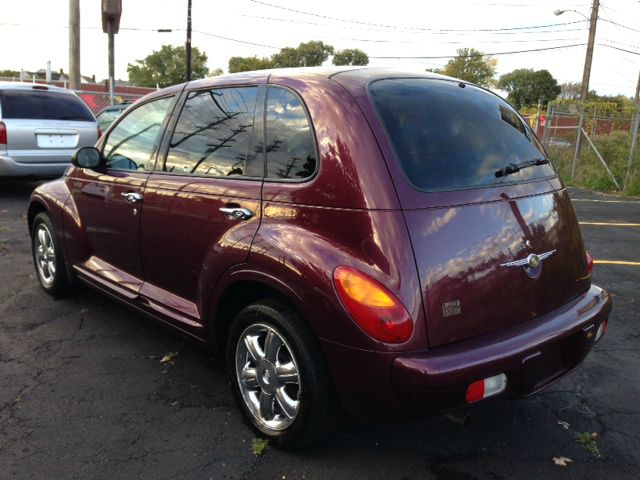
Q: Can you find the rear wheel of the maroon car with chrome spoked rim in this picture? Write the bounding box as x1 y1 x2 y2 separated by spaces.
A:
227 301 335 448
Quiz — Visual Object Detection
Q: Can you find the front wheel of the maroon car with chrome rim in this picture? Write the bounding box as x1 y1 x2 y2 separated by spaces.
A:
31 212 69 297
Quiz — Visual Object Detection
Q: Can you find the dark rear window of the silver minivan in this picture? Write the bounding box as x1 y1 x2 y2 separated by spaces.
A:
0 90 94 122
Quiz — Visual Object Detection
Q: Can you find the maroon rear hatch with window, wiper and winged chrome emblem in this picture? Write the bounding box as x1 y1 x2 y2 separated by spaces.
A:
369 78 590 347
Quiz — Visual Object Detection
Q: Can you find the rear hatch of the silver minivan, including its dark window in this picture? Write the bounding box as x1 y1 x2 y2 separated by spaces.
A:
0 87 98 163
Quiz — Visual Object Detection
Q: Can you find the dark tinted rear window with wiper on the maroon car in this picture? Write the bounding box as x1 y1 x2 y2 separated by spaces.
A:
370 78 554 191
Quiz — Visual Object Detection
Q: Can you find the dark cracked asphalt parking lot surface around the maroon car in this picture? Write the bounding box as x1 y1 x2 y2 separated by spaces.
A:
0 183 640 480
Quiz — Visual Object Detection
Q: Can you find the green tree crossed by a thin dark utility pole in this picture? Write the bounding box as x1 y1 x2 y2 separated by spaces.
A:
127 45 209 87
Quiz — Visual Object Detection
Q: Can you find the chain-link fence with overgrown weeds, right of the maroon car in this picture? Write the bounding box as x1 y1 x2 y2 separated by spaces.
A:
524 103 640 195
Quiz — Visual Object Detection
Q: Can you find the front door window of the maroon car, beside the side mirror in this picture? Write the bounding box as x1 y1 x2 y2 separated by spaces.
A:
102 97 173 170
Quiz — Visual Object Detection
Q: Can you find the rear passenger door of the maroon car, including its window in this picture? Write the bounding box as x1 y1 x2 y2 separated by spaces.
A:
140 85 264 335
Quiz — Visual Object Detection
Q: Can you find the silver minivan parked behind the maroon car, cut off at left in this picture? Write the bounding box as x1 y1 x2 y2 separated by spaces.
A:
0 82 99 178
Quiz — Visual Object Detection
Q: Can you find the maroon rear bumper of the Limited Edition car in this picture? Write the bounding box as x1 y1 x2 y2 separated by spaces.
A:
327 286 612 416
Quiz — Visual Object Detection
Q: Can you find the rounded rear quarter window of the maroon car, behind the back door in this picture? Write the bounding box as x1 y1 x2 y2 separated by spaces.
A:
266 87 316 179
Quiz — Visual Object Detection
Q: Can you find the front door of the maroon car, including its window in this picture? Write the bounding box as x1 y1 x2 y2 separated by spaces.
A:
67 96 175 298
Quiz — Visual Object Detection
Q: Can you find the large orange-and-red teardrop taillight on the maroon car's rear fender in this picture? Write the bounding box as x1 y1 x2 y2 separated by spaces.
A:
333 266 413 343
